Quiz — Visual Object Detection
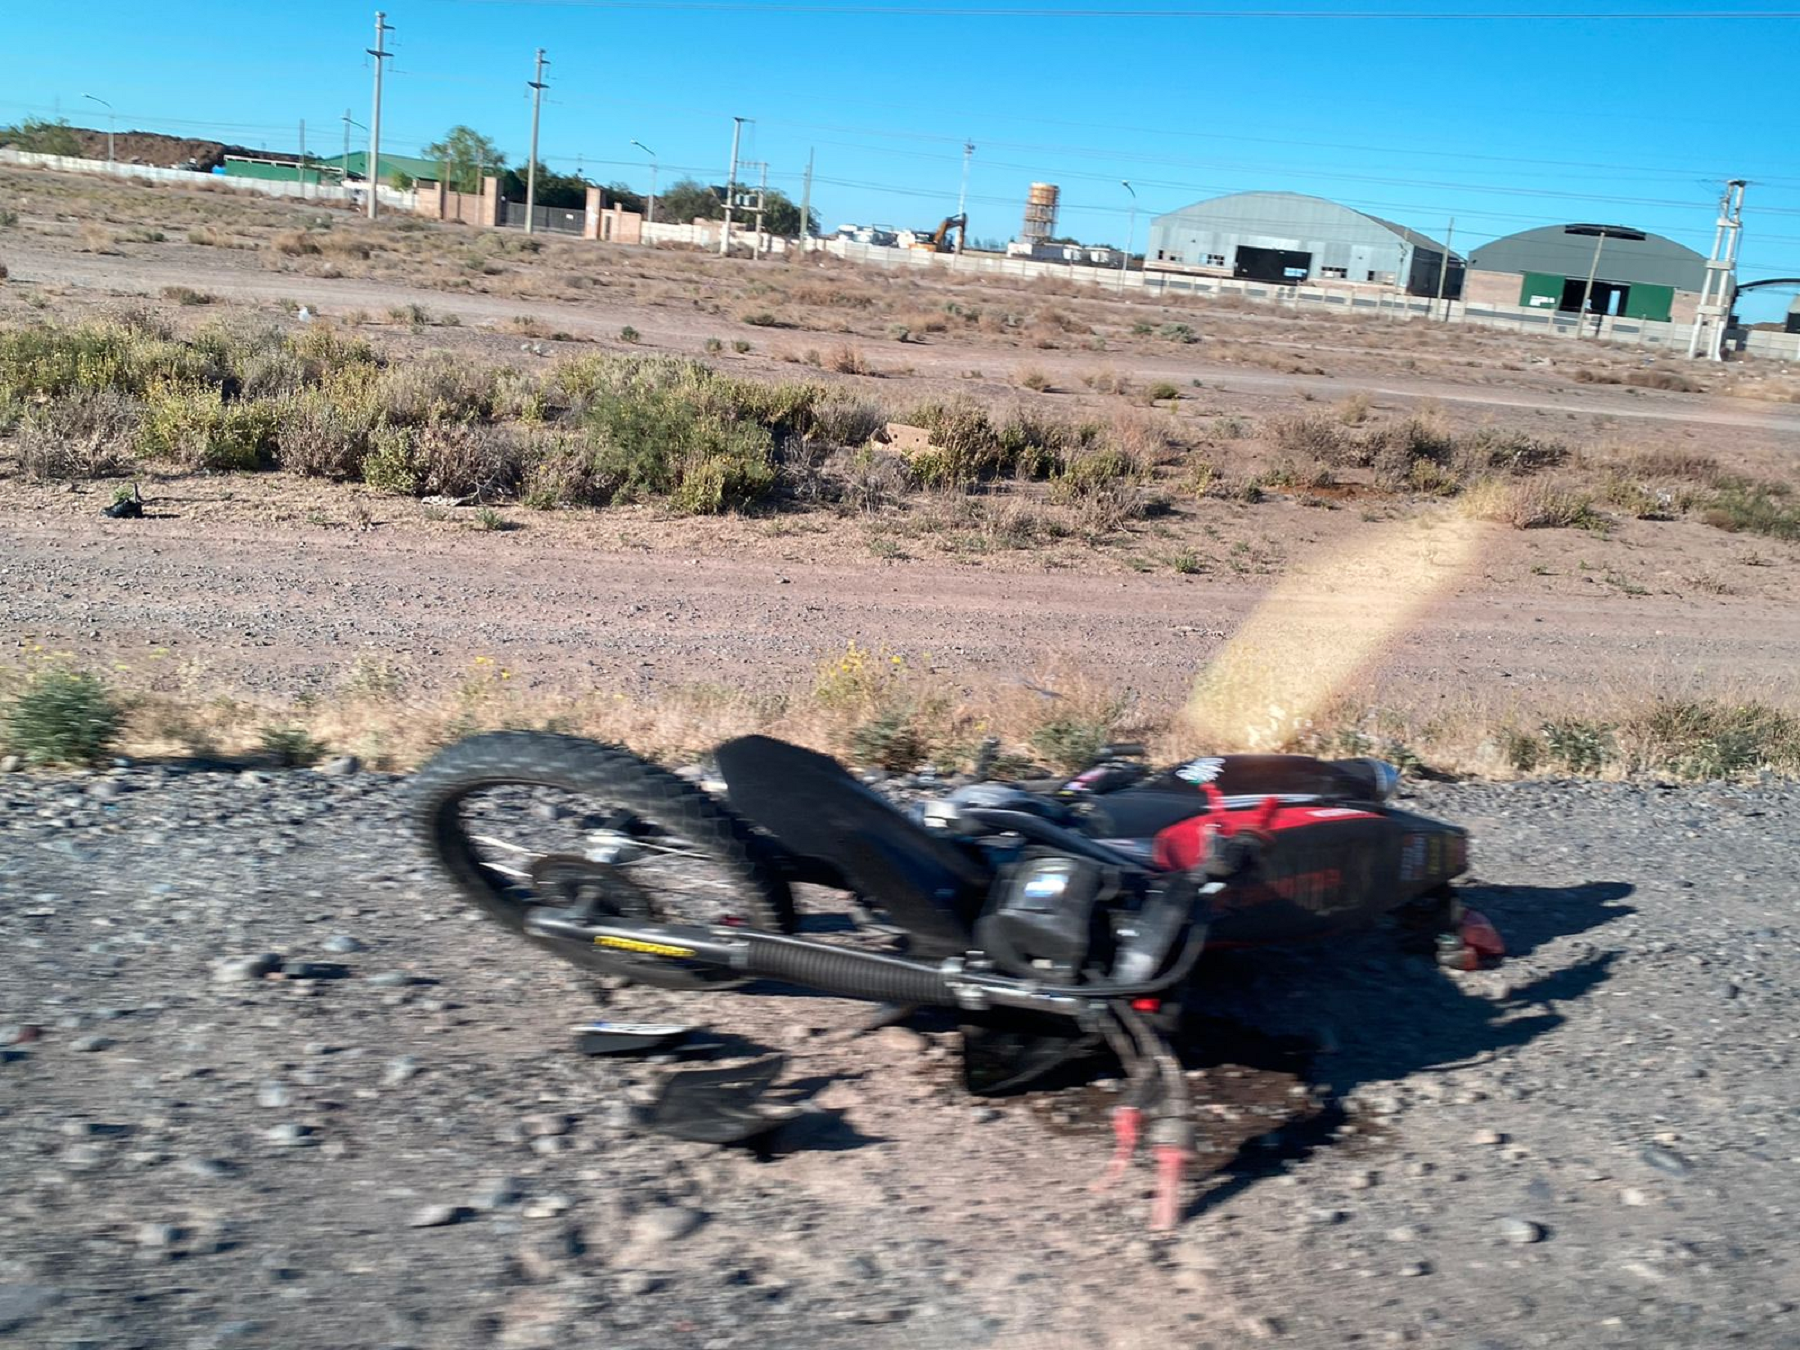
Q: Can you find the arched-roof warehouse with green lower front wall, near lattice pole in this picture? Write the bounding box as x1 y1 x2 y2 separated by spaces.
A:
1465 225 1706 324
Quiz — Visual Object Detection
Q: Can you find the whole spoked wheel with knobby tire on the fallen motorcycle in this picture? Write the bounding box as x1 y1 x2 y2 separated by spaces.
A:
414 731 794 977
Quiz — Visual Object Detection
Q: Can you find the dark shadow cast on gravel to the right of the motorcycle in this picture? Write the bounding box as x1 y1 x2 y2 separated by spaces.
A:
1179 882 1634 1217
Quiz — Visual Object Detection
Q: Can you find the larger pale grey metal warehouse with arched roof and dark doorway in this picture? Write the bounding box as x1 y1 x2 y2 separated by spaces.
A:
1145 193 1463 299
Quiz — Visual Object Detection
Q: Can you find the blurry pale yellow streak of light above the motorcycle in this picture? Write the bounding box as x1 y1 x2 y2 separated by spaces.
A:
1186 517 1492 751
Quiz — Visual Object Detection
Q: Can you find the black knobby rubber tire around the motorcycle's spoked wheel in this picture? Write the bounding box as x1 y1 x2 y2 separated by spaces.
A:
414 731 794 932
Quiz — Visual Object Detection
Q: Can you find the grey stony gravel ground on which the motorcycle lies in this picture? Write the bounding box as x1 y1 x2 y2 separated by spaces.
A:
0 767 1800 1350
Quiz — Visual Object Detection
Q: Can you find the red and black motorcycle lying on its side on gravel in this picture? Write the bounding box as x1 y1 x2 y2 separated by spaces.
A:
416 733 1499 1228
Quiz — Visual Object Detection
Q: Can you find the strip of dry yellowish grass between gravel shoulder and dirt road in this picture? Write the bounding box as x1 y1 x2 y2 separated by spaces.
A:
0 651 1800 779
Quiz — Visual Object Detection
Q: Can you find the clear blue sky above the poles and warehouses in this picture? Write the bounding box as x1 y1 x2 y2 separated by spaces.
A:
0 0 1800 317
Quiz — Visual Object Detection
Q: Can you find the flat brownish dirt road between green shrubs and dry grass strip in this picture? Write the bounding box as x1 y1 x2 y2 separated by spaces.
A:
0 513 1800 720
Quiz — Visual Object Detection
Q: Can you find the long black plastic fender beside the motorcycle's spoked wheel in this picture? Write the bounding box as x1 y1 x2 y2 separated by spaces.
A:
715 736 994 956
